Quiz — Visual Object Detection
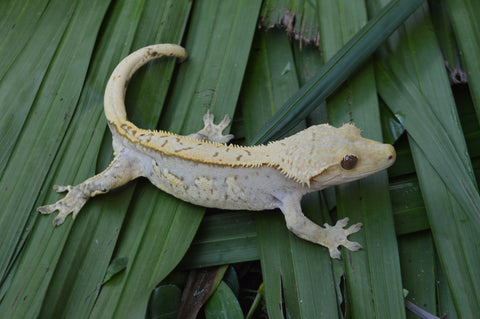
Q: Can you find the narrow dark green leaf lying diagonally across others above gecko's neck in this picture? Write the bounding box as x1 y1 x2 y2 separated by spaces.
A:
254 0 423 144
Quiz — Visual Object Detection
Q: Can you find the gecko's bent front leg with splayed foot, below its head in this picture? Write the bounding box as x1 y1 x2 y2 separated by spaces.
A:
280 195 362 259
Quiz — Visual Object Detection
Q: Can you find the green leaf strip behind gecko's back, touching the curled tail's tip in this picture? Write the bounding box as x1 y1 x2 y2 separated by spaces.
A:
159 0 261 133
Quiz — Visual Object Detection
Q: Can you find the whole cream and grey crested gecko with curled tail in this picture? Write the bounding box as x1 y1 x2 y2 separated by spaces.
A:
37 44 395 258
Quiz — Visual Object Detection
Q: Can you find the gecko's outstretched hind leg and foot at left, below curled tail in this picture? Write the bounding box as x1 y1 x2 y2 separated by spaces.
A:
37 149 144 226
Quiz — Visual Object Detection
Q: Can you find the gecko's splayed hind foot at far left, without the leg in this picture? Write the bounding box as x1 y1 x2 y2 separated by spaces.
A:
37 185 90 226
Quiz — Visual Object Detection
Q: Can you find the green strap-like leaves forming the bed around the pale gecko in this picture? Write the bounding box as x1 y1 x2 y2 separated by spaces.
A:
0 0 480 318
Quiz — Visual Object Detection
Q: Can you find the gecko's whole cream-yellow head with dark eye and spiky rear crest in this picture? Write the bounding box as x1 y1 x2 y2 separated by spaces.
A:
270 124 395 190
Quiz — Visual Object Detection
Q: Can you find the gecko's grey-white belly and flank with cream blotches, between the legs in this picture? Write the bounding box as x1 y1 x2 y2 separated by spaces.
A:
146 149 303 210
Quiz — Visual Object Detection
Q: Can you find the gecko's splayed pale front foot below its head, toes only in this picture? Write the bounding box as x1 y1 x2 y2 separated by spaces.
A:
321 218 362 259
